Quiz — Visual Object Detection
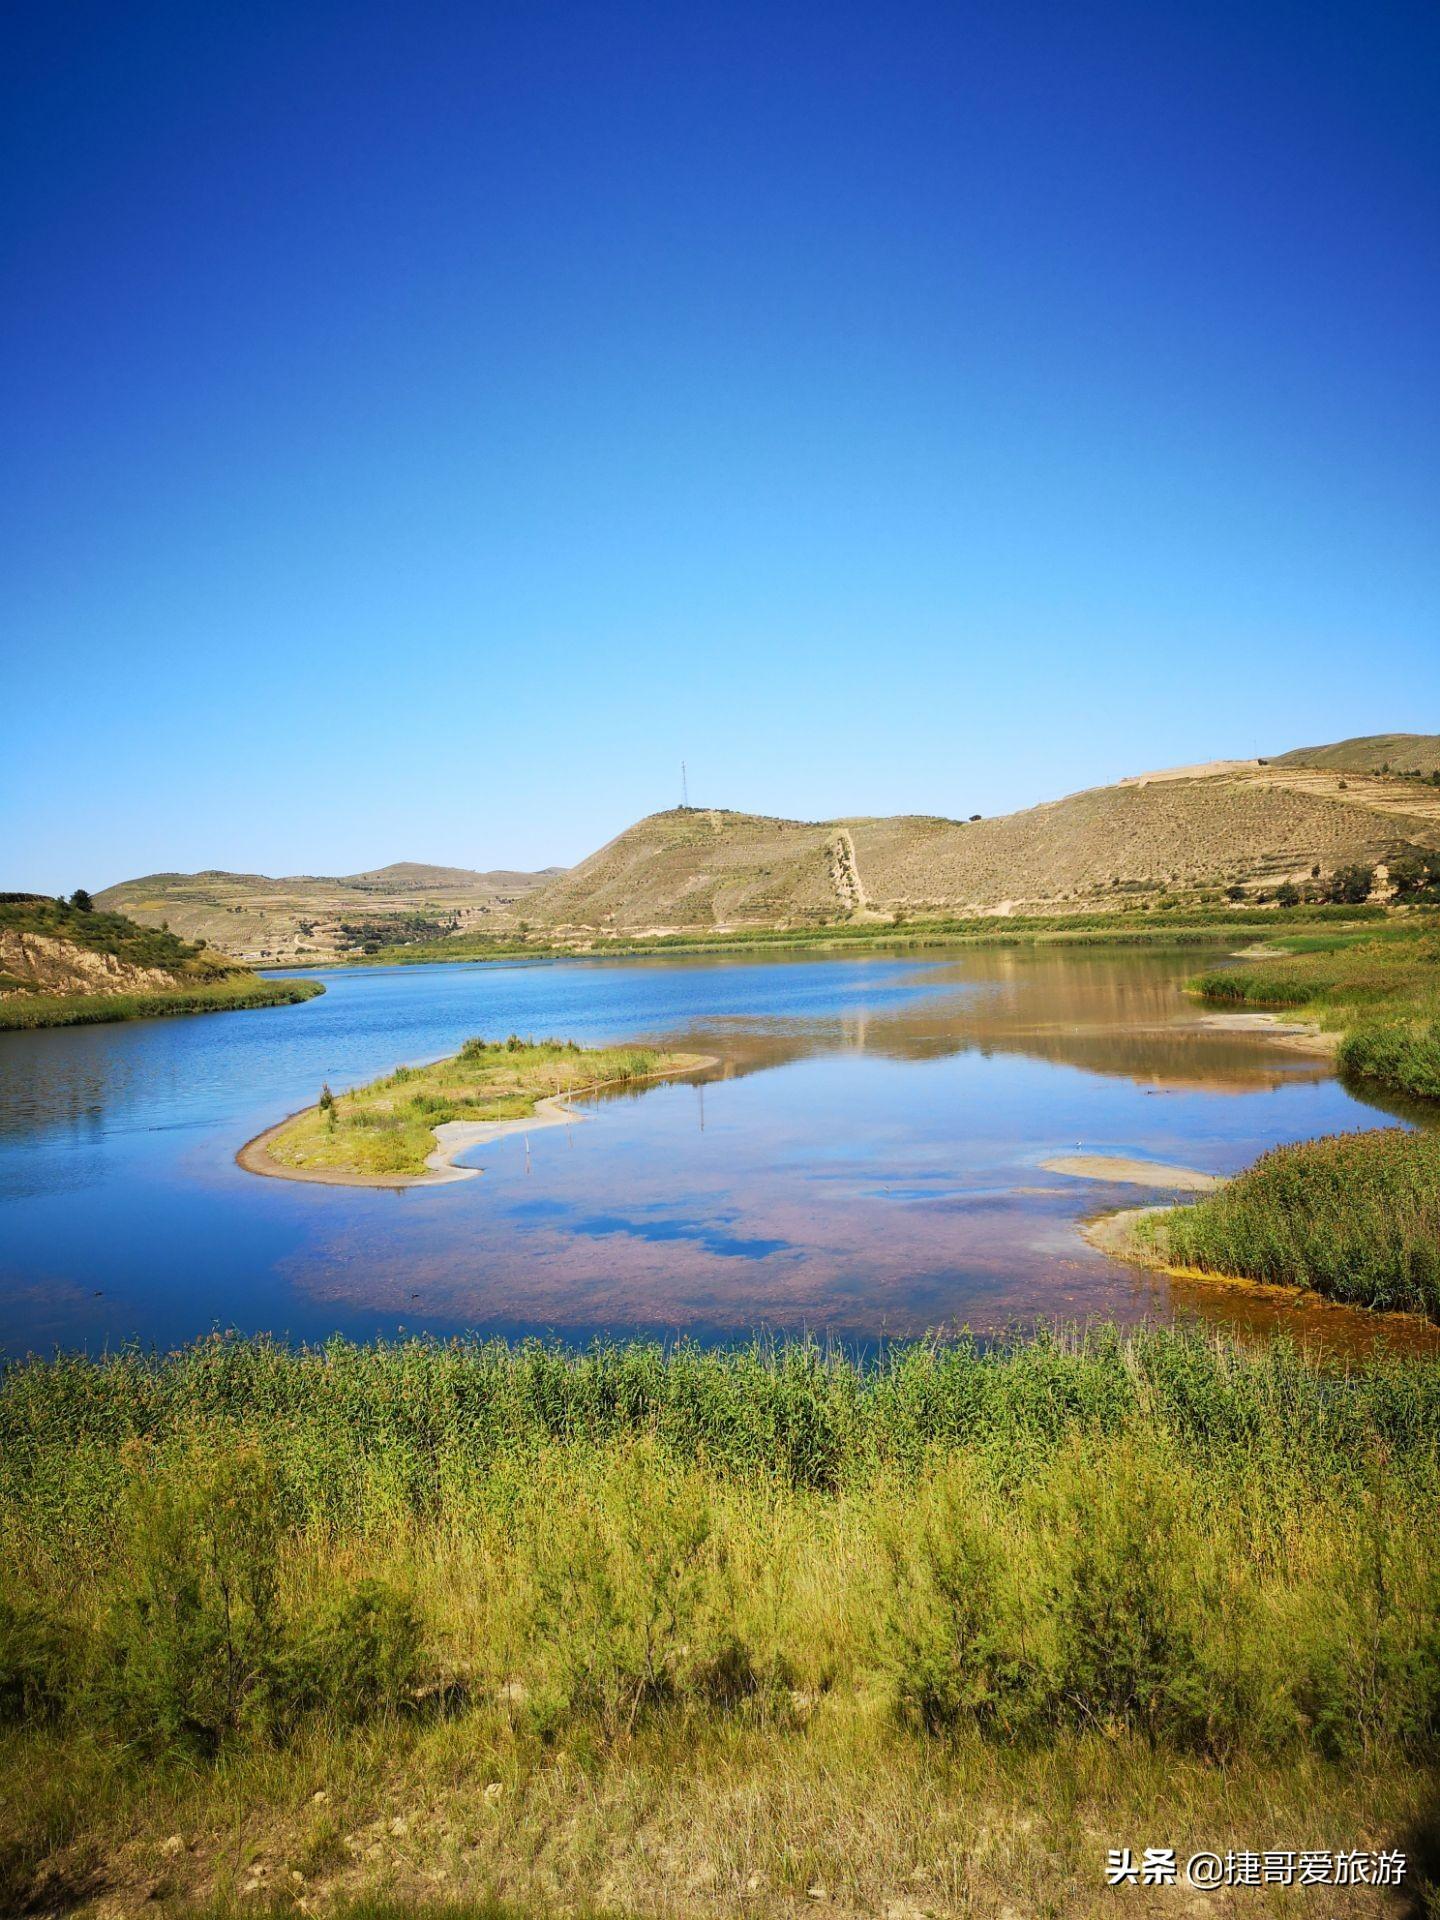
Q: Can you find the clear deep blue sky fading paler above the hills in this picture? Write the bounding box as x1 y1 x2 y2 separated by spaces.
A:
0 0 1440 891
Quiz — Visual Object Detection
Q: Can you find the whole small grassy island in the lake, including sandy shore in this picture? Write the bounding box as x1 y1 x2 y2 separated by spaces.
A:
255 1033 710 1187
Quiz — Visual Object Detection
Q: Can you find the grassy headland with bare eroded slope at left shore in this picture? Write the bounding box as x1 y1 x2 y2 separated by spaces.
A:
0 891 324 1031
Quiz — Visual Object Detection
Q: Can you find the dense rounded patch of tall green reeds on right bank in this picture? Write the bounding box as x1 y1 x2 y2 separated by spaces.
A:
1148 1127 1440 1319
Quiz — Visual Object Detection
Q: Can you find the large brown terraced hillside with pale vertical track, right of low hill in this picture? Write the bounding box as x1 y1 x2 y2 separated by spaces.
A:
522 735 1440 933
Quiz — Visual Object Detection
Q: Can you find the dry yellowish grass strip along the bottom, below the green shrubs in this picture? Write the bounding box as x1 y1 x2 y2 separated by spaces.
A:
14 1699 1434 1920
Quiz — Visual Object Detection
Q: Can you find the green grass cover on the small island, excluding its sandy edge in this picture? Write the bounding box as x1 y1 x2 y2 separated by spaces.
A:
269 1033 699 1173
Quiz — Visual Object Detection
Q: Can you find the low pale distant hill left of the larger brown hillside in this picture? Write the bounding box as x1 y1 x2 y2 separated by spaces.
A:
96 860 563 964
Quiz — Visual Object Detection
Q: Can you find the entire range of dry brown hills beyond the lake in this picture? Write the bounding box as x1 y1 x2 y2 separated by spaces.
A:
96 733 1440 962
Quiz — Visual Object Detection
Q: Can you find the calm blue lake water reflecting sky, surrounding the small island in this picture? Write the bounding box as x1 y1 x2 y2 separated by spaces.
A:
0 948 1423 1354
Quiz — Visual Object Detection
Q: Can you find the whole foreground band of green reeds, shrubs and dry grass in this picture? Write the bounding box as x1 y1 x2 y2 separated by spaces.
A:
0 1329 1440 1914
